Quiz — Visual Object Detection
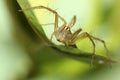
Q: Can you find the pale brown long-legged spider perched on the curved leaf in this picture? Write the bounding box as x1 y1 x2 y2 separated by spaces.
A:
20 6 107 54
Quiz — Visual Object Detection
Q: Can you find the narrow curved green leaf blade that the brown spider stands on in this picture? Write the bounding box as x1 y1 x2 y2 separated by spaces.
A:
17 0 114 64
